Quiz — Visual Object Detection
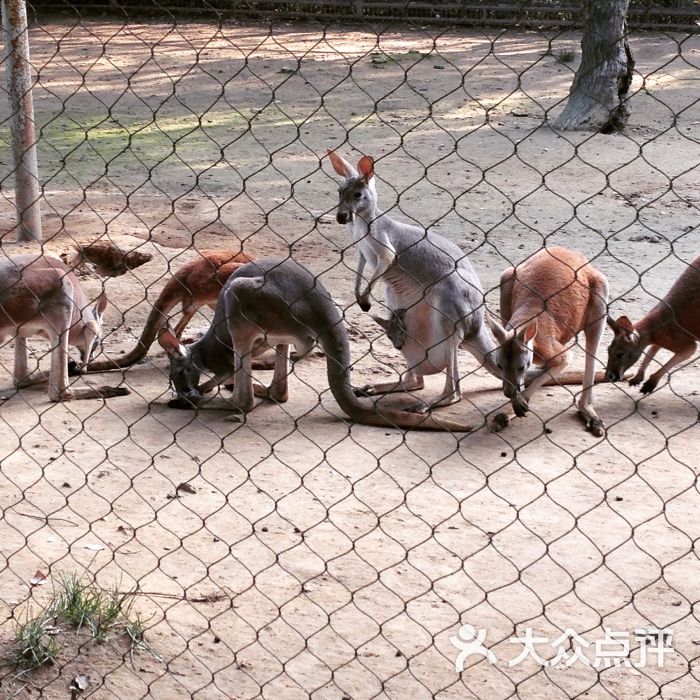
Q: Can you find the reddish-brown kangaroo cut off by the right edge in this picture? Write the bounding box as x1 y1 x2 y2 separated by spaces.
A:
607 257 700 394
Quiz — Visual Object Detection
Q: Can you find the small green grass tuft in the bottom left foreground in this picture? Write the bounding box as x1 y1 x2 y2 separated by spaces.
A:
12 573 150 673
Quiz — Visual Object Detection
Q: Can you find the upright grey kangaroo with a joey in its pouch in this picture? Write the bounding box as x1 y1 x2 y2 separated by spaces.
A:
328 150 500 412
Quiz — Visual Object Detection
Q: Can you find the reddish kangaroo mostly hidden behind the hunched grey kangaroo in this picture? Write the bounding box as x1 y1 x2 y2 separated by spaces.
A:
87 250 252 372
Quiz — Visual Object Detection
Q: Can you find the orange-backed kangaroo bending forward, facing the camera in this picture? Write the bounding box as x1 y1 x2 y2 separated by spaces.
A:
488 247 608 437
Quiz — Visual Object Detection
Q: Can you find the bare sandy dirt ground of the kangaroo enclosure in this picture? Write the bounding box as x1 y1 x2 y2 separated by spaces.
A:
0 16 700 700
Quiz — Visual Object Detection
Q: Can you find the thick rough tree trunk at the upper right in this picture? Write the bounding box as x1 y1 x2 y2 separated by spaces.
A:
552 0 634 133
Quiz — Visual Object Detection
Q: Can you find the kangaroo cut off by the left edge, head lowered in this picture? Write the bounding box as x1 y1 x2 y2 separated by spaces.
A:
0 254 129 401
